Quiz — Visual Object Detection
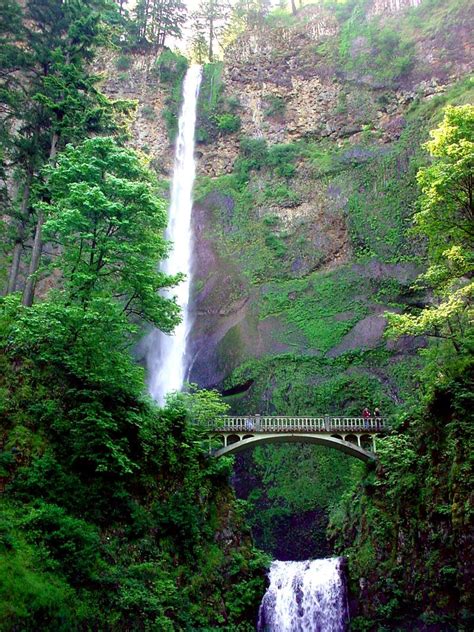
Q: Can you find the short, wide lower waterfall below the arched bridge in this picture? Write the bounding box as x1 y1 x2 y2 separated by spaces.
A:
257 558 348 632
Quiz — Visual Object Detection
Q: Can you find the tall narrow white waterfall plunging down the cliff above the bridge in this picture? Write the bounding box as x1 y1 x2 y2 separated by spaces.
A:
146 66 201 404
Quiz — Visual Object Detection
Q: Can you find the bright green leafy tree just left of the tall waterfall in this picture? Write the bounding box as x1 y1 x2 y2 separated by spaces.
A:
38 137 180 332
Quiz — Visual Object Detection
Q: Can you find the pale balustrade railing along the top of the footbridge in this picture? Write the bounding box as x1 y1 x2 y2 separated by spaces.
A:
209 415 389 433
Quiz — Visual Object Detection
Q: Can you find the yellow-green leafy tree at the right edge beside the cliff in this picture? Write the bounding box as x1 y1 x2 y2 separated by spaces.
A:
389 105 474 351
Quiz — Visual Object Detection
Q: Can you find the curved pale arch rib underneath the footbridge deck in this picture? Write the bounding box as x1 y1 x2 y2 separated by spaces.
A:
214 433 375 462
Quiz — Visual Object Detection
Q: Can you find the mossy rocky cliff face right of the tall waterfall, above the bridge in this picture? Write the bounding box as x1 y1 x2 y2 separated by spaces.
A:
187 0 472 413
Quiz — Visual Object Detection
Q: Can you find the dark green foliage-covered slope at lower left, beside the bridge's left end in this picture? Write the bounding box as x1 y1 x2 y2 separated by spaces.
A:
0 296 266 630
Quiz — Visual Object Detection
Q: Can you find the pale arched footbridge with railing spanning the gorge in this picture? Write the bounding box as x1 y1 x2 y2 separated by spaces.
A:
209 415 388 461
